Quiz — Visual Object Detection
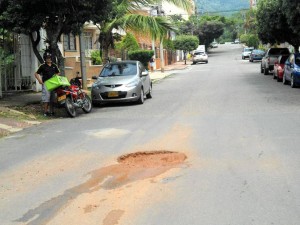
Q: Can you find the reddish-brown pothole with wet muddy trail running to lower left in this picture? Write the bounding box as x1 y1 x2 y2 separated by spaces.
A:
17 151 187 224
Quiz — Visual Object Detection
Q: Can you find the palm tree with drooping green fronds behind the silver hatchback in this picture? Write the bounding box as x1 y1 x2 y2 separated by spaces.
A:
99 0 191 63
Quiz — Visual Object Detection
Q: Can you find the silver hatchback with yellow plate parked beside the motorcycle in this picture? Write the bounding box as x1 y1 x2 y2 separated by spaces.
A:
91 60 152 105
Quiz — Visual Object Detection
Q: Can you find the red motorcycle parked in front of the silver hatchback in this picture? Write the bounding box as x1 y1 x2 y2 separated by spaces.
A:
55 79 92 117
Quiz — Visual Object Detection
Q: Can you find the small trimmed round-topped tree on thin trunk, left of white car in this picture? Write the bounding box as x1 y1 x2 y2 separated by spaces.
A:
174 35 199 64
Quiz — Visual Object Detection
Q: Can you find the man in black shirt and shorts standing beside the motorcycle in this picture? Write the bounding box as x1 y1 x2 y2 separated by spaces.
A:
34 52 59 116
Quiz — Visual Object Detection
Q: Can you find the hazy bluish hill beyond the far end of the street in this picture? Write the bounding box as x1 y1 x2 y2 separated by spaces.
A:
195 0 250 14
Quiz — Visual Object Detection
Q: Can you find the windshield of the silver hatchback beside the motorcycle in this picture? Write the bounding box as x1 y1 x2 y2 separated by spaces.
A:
100 63 137 77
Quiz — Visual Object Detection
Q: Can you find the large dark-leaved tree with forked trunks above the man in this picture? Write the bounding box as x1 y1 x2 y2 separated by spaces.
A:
0 0 112 74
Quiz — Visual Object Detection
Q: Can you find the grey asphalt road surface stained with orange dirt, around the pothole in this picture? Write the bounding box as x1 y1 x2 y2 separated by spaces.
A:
0 44 300 225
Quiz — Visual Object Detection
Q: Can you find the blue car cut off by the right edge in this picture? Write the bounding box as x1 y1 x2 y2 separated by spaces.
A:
282 53 300 88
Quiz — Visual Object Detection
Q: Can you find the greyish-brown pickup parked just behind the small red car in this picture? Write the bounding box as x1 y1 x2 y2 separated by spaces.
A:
260 48 290 75
